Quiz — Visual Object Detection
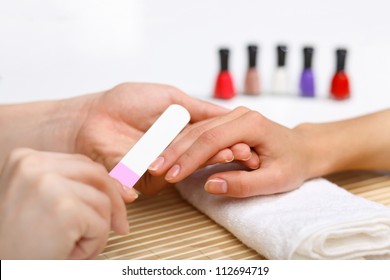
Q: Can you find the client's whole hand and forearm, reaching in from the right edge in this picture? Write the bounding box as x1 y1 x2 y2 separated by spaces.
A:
150 107 390 197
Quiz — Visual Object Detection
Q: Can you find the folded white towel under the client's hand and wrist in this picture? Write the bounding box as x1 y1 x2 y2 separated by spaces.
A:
176 166 390 259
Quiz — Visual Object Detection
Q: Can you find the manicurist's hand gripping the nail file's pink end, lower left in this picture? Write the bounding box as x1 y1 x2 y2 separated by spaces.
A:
0 149 137 259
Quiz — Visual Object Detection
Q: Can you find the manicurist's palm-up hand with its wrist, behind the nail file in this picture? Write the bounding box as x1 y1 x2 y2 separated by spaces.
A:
0 83 229 196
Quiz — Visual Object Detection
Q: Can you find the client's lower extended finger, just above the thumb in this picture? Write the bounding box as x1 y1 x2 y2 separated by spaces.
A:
165 111 264 183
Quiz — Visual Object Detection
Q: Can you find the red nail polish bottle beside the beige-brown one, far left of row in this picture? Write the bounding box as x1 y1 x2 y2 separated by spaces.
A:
214 49 236 99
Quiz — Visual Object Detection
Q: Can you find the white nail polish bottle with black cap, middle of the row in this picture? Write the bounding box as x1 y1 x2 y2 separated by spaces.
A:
271 45 289 94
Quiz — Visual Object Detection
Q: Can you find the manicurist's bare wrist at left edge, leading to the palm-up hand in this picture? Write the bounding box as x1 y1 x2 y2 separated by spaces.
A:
0 95 92 156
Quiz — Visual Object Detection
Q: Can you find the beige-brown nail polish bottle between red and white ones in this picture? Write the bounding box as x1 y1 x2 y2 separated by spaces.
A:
244 45 260 95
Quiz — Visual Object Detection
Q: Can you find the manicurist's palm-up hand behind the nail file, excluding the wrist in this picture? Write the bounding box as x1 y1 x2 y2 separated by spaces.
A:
68 84 228 194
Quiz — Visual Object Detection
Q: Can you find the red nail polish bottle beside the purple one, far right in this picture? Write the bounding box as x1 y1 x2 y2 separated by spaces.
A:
330 49 350 100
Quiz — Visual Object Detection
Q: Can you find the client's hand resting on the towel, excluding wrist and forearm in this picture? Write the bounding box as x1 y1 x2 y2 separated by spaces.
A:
151 107 310 197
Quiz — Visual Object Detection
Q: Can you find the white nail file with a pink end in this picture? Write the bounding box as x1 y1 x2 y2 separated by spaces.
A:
110 104 190 188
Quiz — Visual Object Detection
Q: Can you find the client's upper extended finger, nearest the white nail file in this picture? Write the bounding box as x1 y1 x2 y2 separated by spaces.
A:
149 107 249 176
